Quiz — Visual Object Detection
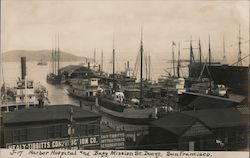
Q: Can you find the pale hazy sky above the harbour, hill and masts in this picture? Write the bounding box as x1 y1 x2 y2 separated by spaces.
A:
1 0 250 65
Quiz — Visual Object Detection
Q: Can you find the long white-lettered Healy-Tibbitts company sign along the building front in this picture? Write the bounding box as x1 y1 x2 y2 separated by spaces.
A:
6 135 100 149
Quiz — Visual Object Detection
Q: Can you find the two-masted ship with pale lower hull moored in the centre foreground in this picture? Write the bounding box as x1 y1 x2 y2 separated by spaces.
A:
96 29 164 124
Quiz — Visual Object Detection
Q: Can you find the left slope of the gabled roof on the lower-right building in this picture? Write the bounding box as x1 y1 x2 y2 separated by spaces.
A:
152 112 197 135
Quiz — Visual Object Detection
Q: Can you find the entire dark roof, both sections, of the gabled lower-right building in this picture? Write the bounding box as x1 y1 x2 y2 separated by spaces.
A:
152 108 248 136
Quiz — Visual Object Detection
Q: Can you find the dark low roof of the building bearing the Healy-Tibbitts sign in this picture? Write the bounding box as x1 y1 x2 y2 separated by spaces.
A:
3 105 101 124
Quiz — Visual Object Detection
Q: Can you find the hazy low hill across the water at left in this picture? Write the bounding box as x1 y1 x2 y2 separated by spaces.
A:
2 50 89 62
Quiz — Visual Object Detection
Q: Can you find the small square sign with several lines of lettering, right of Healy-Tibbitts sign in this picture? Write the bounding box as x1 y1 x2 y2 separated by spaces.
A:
101 132 125 149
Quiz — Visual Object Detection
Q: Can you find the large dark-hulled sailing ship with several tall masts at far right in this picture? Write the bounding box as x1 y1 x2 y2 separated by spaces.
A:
186 25 249 97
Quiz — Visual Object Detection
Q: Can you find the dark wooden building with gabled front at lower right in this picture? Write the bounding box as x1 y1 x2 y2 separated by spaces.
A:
146 108 248 151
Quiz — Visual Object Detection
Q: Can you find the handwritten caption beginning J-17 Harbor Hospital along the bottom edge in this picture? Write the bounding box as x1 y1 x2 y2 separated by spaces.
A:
8 149 212 158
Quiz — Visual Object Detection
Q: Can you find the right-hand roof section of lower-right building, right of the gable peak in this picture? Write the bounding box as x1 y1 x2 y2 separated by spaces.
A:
182 108 247 128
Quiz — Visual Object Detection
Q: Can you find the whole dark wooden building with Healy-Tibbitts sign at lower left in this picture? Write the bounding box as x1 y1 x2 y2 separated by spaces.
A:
2 105 101 149
